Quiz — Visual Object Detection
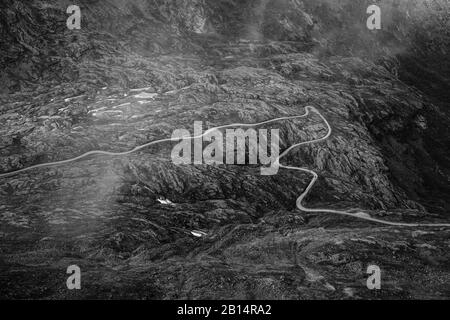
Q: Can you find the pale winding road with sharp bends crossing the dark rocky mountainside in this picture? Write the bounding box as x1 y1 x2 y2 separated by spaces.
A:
0 106 450 227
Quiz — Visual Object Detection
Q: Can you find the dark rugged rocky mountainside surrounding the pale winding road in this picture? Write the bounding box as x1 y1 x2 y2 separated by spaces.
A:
0 0 450 299
